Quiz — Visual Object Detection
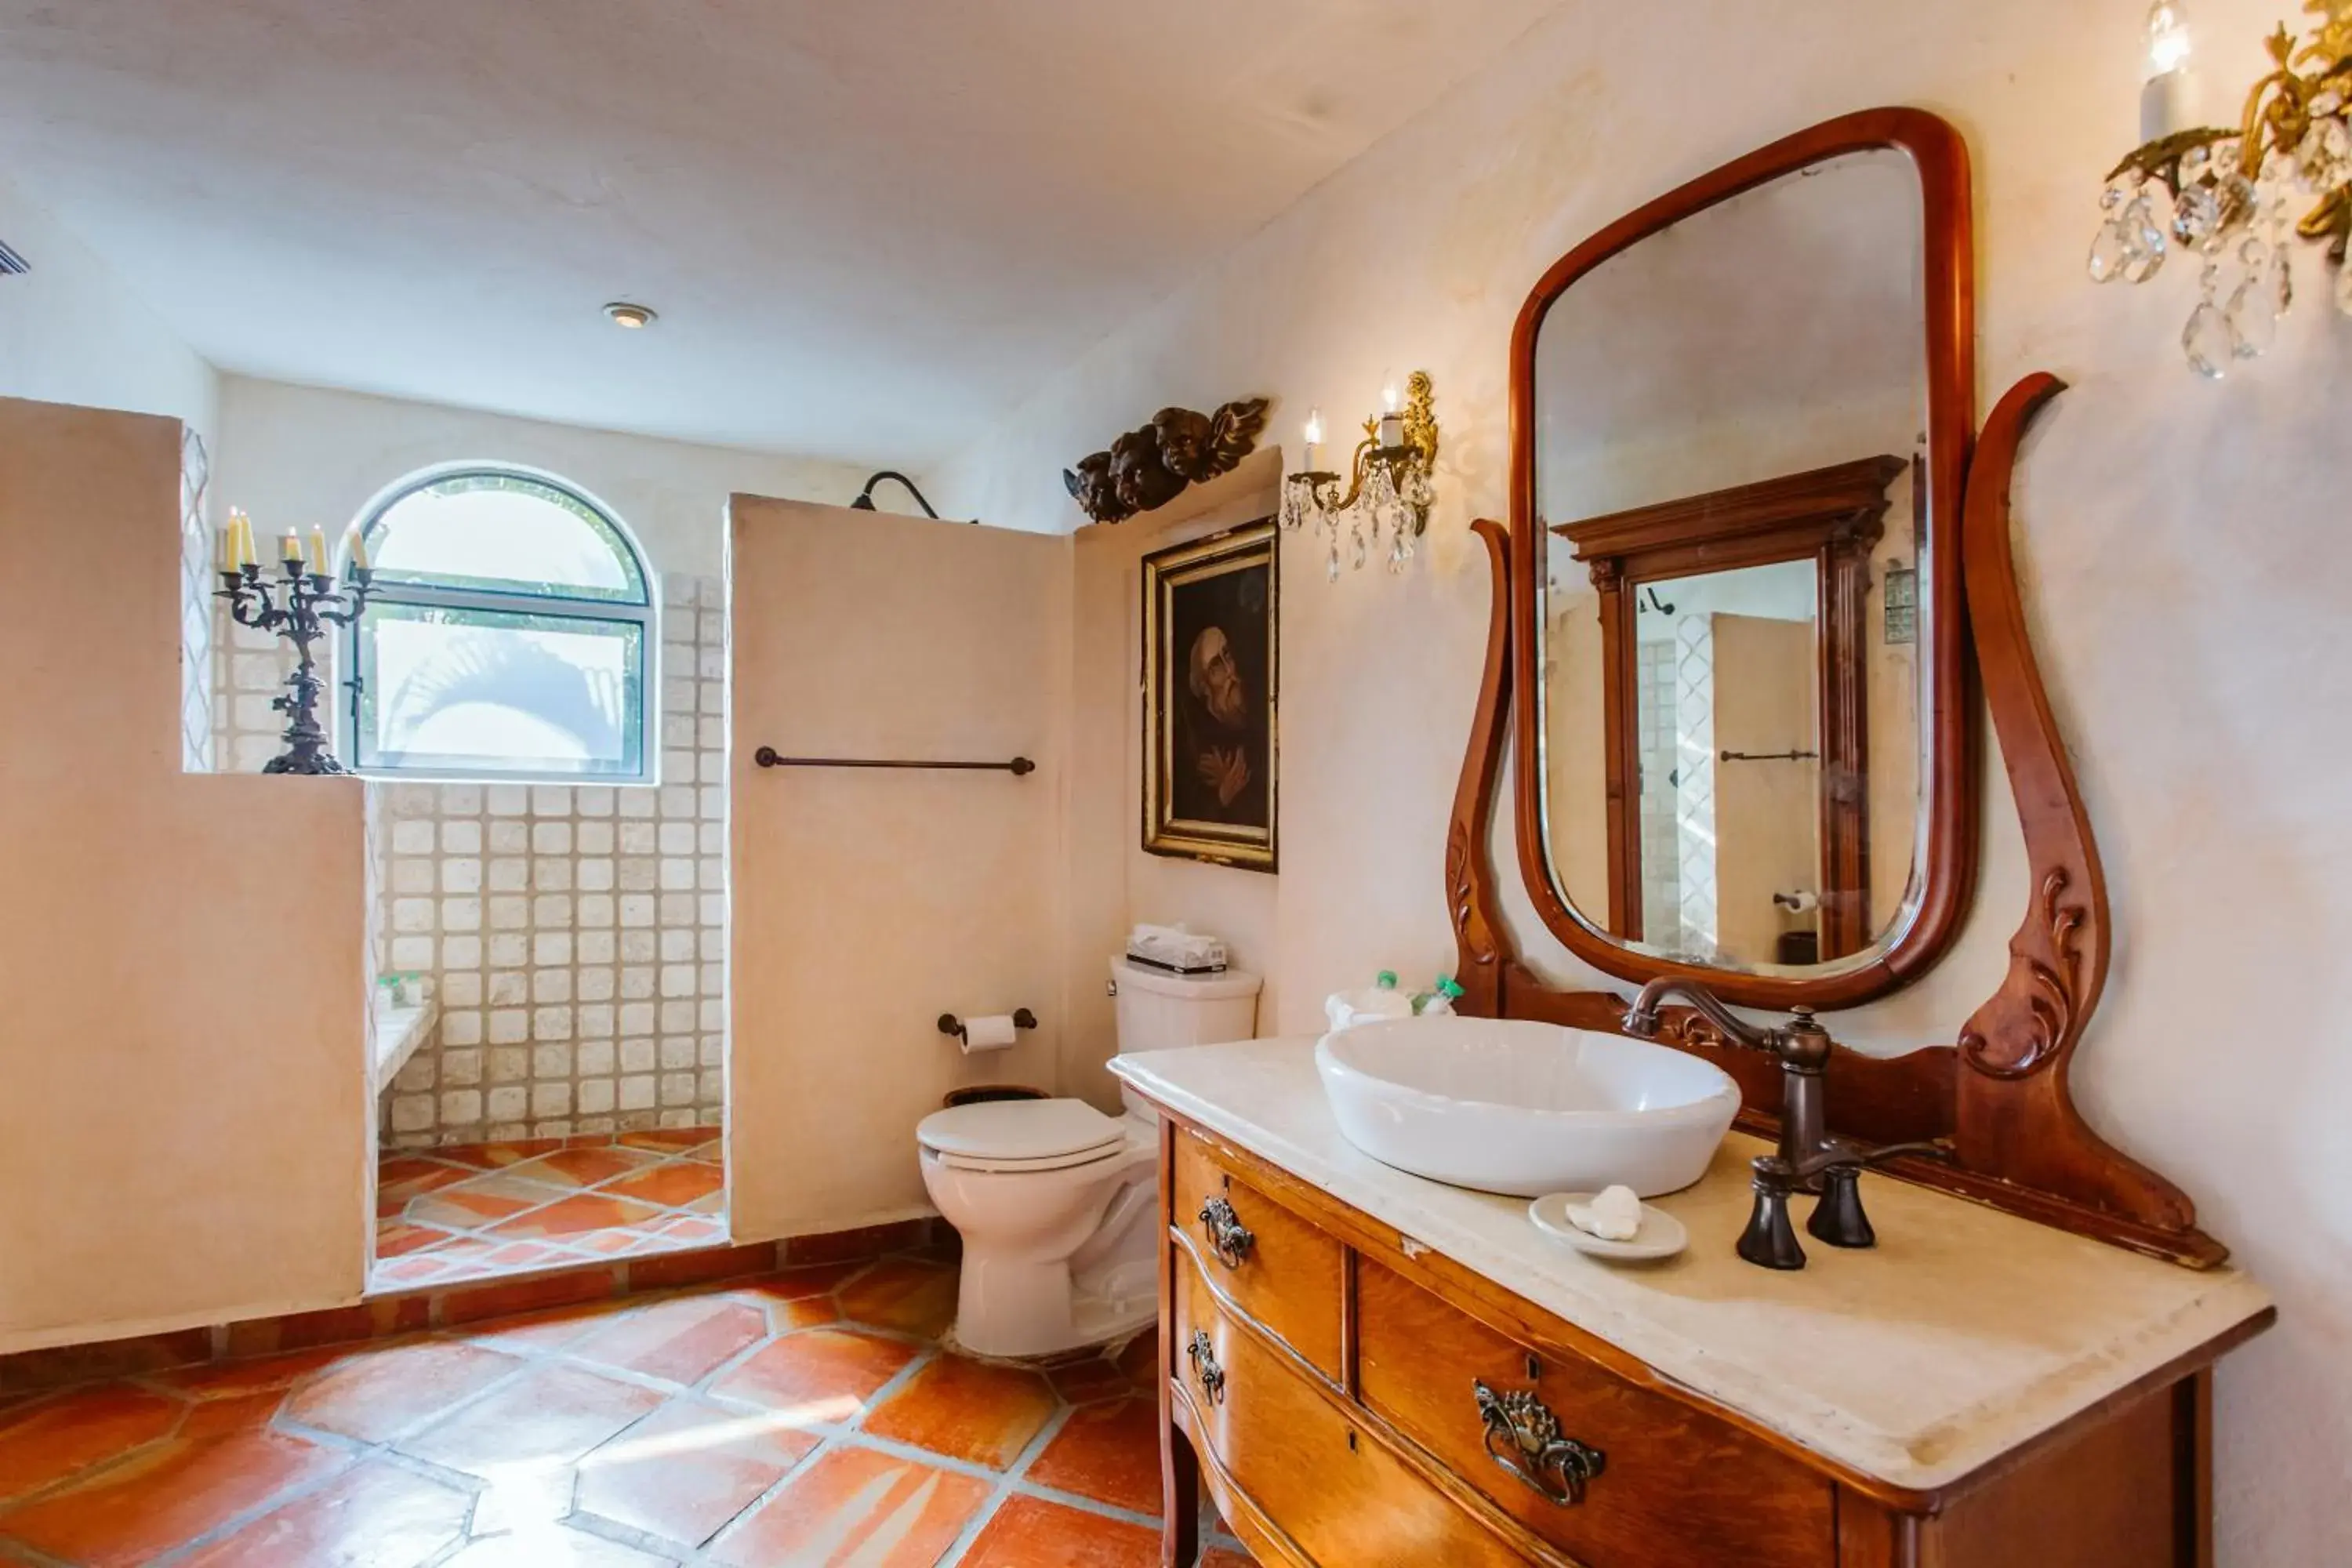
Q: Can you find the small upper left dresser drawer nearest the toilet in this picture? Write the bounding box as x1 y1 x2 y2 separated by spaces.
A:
1169 1133 1348 1382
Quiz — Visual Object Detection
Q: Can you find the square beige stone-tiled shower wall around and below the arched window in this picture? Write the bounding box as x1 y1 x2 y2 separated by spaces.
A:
214 576 727 1147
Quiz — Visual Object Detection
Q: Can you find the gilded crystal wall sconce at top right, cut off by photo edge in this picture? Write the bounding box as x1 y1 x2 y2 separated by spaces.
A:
2091 0 2352 381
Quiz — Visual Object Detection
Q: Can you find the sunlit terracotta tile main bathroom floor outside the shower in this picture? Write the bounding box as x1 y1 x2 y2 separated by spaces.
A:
0 1255 1249 1568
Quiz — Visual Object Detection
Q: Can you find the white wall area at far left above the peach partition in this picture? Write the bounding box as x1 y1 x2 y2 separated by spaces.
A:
0 179 219 445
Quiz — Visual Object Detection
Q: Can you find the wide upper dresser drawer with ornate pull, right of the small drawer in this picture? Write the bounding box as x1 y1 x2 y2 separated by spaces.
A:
1357 1258 1837 1568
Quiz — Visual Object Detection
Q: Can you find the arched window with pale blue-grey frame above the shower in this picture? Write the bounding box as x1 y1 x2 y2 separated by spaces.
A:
348 468 656 783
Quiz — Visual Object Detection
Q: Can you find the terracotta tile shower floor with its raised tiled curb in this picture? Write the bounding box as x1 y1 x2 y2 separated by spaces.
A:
367 1126 727 1290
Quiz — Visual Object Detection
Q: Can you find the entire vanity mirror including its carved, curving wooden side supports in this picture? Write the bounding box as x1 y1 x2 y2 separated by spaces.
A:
1446 108 2225 1265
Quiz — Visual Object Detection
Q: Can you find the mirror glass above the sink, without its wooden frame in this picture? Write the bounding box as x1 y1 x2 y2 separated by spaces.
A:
1534 148 1931 975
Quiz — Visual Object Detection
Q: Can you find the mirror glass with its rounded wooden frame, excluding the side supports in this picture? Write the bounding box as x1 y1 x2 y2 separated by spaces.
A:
1512 111 1976 1006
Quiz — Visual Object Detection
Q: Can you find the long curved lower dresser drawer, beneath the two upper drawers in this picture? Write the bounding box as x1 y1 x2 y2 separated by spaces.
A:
1169 1258 1524 1568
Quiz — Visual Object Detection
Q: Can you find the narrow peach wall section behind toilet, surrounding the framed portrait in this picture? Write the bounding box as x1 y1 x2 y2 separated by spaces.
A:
1061 460 1289 1109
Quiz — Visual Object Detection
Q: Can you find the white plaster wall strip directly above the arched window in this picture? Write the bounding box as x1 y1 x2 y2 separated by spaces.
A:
212 376 875 576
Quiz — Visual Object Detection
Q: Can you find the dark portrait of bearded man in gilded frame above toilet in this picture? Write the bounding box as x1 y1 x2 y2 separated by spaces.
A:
1143 517 1279 872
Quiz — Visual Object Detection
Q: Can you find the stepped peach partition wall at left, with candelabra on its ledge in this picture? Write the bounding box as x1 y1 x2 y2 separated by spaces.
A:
0 400 372 1352
